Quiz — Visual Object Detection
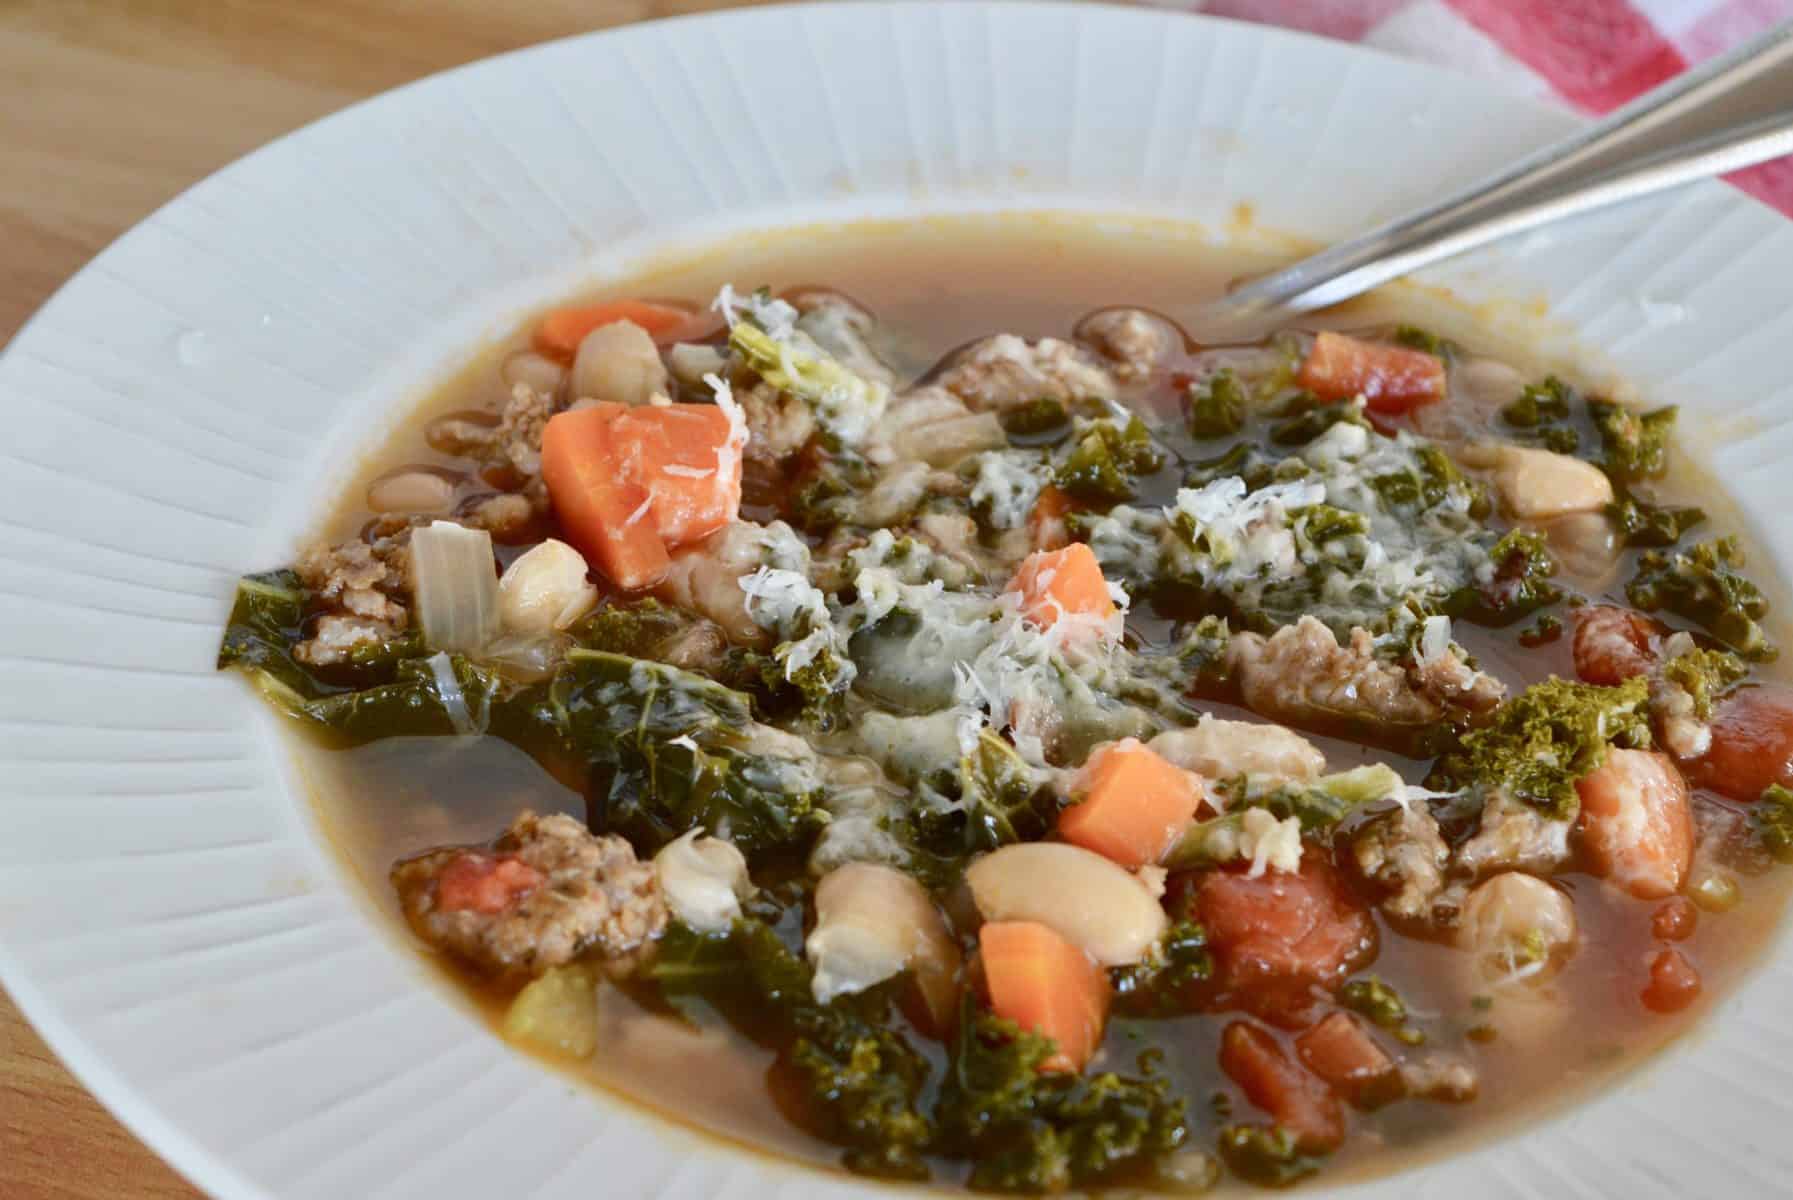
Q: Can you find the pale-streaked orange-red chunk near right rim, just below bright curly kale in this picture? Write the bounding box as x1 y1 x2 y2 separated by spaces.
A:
1576 748 1693 900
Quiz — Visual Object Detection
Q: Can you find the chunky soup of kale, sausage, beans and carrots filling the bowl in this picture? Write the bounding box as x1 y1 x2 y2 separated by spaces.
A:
222 219 1793 1193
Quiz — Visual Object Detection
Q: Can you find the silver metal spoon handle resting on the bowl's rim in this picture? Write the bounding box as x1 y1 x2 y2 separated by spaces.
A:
1194 22 1793 341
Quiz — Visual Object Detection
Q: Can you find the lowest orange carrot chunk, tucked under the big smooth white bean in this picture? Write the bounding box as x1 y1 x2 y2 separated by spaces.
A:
977 920 1110 1071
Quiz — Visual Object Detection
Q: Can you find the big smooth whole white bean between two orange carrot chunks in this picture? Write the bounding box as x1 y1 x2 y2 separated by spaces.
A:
965 841 1169 967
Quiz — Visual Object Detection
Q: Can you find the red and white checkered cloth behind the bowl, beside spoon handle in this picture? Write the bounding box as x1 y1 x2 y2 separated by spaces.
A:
1160 0 1793 215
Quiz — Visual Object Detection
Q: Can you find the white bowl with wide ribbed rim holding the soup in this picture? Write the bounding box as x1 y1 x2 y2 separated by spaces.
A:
0 4 1793 1200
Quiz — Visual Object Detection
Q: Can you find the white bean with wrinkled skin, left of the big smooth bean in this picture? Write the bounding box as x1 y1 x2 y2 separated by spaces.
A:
803 863 959 1017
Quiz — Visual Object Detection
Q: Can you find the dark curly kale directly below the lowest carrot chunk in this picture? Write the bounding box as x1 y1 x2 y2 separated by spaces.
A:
936 1004 1189 1193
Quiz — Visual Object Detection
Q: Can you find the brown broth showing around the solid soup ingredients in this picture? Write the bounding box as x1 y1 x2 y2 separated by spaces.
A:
290 217 1793 1180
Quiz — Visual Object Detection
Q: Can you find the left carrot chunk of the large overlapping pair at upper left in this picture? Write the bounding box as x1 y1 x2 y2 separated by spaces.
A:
541 405 672 592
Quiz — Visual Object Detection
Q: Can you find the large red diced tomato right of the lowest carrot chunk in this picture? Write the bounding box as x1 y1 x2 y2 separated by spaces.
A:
1194 856 1377 1028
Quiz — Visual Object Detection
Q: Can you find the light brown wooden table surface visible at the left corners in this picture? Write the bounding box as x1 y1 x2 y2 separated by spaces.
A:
0 0 763 1200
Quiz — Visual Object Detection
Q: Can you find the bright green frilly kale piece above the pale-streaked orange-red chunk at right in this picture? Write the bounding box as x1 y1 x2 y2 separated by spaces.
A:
1427 676 1651 818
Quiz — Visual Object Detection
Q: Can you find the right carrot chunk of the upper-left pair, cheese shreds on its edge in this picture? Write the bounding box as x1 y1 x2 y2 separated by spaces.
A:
610 404 741 547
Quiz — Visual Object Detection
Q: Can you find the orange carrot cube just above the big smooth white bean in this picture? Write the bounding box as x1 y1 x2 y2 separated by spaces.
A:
1058 737 1201 870
